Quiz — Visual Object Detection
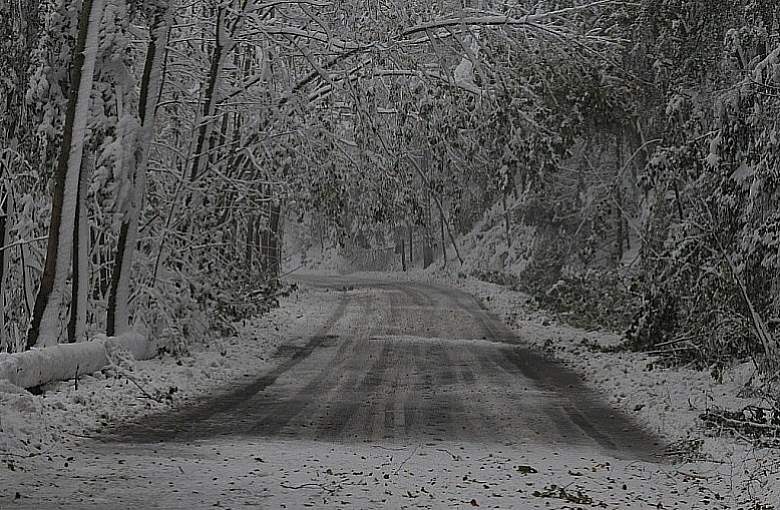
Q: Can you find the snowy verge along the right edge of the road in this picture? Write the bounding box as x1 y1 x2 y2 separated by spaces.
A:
340 268 780 510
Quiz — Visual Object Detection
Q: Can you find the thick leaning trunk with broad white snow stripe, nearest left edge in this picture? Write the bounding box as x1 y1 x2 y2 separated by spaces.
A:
26 0 104 349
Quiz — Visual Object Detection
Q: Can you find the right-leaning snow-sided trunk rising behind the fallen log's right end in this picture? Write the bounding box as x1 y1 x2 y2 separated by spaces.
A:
106 1 175 336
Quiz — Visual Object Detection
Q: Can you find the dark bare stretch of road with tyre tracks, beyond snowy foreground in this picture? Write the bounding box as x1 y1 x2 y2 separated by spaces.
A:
106 276 659 459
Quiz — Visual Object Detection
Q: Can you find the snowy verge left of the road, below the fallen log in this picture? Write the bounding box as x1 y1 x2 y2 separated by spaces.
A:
0 284 336 469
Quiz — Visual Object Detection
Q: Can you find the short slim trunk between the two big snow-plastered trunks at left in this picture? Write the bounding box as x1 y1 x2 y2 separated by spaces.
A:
68 151 94 343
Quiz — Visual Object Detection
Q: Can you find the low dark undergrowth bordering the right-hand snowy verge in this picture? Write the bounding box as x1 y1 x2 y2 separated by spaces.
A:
472 262 766 379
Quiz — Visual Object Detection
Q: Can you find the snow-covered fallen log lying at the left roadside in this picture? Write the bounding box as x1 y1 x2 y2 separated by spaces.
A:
0 332 152 388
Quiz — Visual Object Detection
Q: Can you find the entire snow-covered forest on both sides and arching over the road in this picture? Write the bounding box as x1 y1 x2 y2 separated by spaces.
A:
0 0 780 436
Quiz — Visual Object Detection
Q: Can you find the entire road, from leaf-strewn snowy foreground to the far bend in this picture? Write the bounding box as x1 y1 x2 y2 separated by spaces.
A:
0 276 732 509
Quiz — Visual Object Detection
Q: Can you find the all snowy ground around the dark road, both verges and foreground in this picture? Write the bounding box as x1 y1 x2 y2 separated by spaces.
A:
0 273 780 510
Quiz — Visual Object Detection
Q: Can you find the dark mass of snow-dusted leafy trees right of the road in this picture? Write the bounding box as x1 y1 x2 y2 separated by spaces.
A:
386 0 780 374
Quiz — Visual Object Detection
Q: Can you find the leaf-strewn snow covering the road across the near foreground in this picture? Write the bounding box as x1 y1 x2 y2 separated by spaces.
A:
0 439 744 510
